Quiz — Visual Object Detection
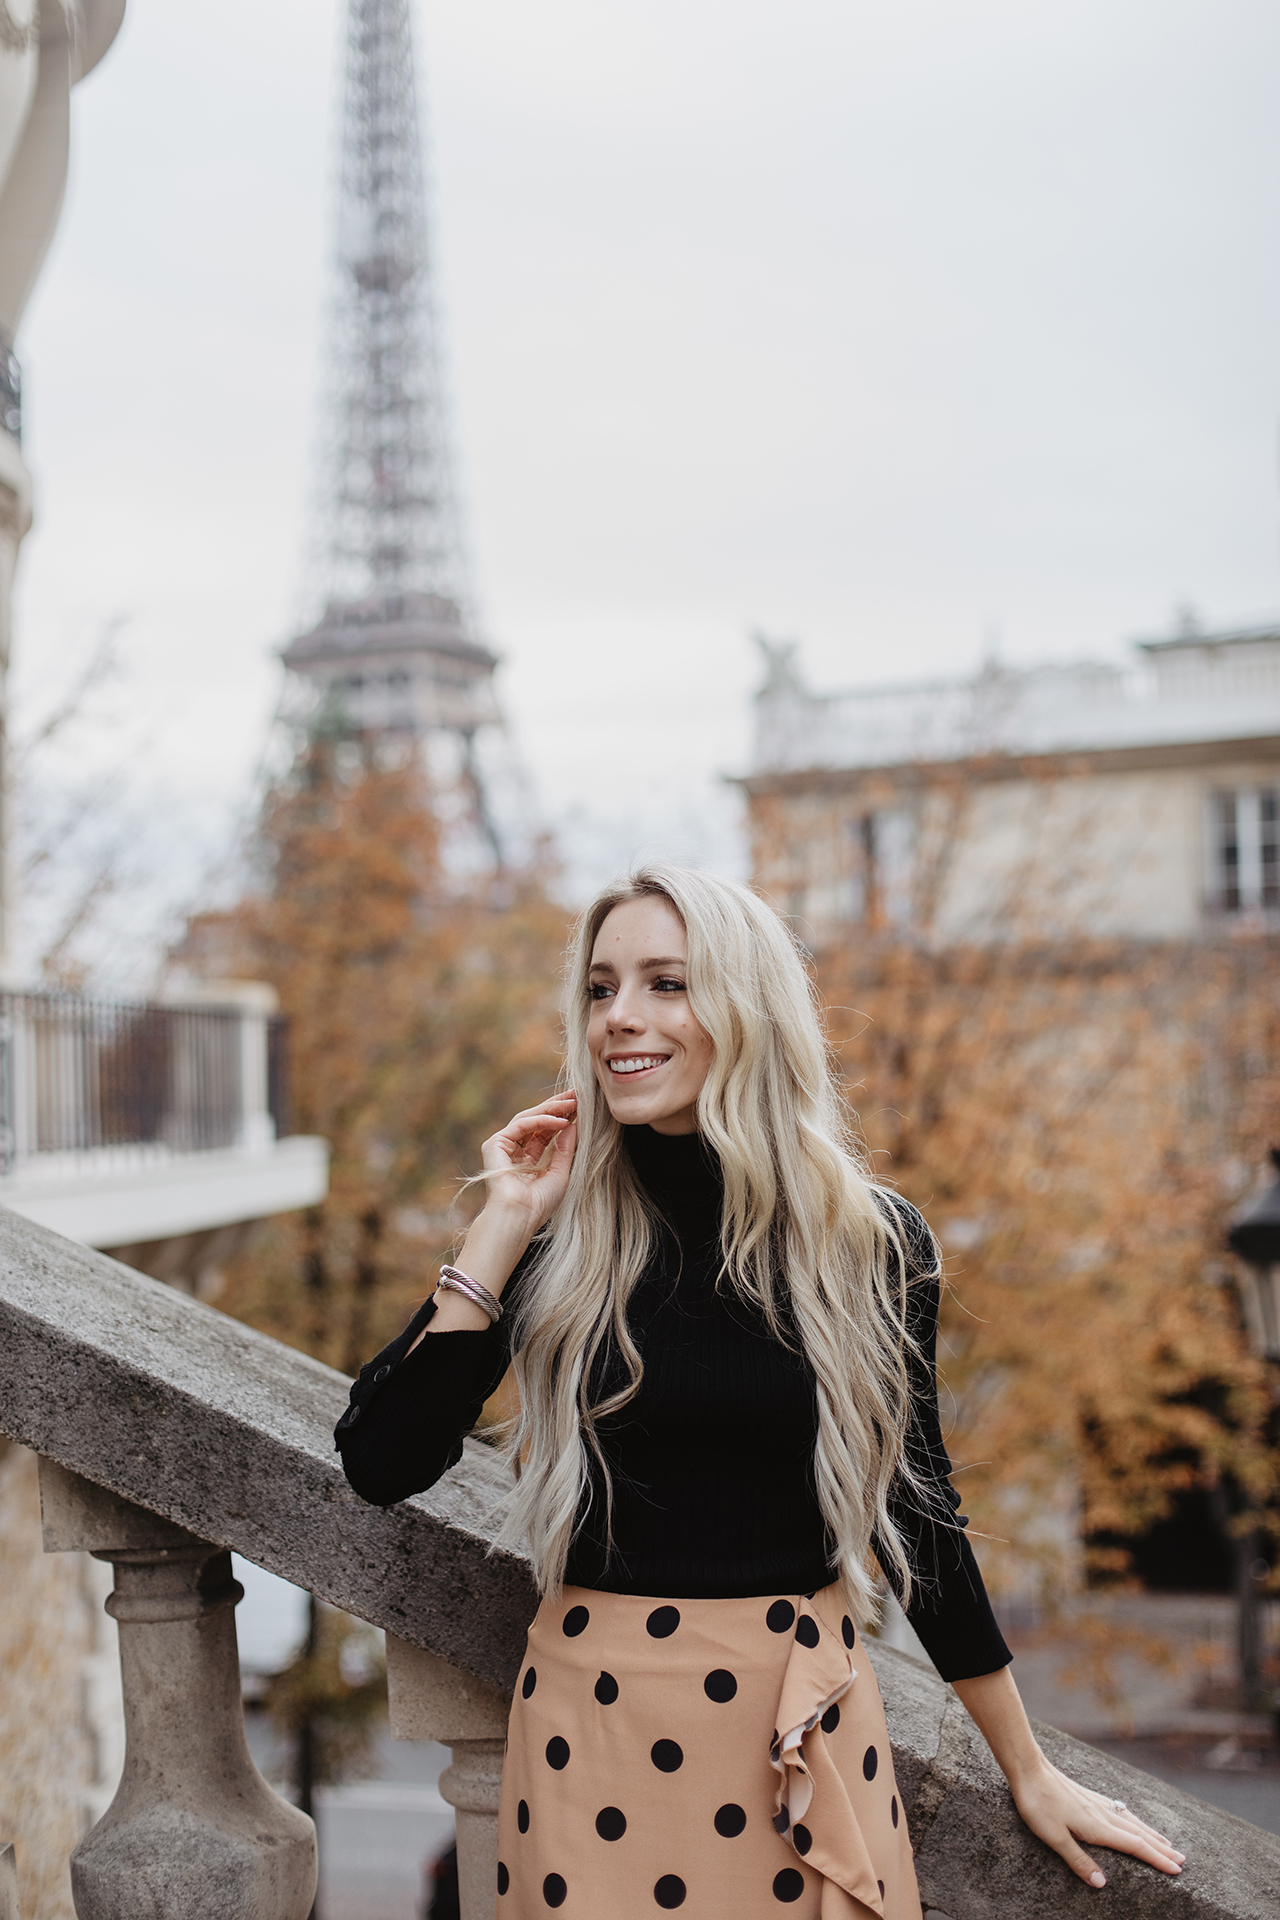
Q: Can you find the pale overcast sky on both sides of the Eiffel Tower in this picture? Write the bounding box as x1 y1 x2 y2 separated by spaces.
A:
17 0 1280 952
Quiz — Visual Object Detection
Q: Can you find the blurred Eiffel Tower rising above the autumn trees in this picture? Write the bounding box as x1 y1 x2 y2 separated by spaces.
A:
282 0 503 866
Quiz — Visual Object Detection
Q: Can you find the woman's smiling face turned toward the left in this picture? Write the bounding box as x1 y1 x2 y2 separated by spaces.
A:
587 895 712 1133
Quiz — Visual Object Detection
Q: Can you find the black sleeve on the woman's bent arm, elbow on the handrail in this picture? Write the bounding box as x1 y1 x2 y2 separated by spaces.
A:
334 1269 520 1507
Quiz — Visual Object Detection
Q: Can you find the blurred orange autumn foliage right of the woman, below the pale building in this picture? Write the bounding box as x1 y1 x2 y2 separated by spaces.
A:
818 939 1280 1603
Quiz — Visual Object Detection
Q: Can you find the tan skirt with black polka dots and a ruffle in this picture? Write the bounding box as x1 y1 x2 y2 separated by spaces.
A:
495 1586 921 1920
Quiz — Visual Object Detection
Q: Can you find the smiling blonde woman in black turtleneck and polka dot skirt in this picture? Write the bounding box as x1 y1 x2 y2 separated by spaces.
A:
338 868 1182 1920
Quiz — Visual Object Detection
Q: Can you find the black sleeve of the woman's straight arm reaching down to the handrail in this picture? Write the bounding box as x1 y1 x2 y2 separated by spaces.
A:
875 1200 1013 1680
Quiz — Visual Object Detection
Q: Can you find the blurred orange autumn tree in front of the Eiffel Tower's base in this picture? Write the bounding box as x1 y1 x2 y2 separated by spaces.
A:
223 739 566 1371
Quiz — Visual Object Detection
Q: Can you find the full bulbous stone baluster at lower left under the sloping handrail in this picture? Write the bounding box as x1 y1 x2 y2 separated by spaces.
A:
40 1459 317 1920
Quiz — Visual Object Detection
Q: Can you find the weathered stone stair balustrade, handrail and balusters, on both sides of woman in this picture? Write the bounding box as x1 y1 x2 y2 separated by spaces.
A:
0 1210 1280 1920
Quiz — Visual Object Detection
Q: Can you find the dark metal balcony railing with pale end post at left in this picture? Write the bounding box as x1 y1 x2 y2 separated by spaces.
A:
0 993 286 1173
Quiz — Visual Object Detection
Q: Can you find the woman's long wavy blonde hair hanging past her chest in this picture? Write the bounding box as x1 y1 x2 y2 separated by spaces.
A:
499 866 932 1619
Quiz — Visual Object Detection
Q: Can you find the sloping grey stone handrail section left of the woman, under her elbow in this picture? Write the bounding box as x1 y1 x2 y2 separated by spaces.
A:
0 1210 537 1688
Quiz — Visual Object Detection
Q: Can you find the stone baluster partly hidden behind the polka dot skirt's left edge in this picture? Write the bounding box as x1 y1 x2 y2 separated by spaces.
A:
386 1634 510 1920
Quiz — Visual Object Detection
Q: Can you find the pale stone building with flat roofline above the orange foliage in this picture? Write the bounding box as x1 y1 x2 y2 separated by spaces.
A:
743 624 1280 945
